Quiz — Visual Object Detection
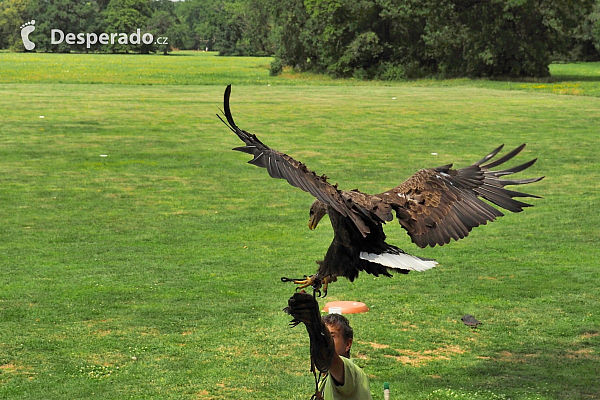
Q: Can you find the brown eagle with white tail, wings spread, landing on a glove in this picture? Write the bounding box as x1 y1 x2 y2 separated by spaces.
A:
217 85 544 295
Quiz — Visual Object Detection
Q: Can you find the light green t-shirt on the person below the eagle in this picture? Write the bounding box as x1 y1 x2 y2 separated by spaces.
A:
321 357 373 400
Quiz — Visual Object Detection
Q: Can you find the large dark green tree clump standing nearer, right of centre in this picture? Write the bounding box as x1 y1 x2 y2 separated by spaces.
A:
276 0 594 78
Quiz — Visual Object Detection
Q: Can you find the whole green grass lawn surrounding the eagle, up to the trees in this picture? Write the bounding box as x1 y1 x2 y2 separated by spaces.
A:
0 53 600 400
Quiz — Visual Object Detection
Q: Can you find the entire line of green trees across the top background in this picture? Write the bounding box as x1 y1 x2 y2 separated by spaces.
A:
0 0 600 80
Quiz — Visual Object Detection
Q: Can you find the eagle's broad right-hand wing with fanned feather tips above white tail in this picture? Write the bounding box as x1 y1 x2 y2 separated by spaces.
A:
376 144 544 247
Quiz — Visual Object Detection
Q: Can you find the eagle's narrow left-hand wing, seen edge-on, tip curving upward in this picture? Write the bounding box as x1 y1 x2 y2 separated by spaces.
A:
217 85 369 236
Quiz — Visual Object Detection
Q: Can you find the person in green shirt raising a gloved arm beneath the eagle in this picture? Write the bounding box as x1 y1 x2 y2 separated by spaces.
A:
284 292 372 400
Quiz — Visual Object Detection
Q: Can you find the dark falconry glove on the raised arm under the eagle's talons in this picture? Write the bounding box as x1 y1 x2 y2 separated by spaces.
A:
283 292 335 373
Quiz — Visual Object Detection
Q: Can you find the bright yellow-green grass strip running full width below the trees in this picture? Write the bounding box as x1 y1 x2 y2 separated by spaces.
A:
0 51 600 97
